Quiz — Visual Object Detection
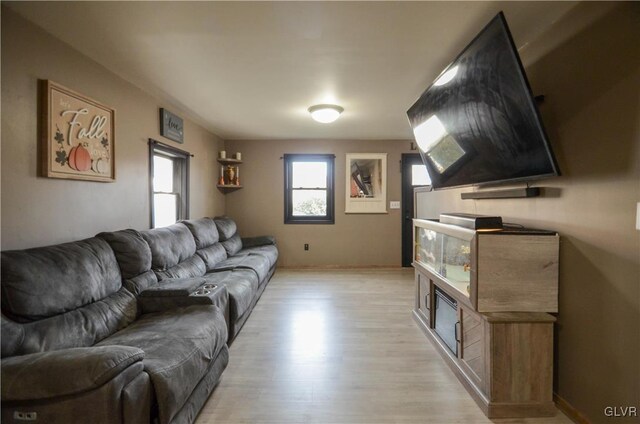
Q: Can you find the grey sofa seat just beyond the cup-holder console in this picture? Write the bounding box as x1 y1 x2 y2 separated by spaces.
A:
205 269 258 322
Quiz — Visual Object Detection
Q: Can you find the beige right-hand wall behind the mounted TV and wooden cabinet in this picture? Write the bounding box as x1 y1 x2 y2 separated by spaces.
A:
418 3 640 423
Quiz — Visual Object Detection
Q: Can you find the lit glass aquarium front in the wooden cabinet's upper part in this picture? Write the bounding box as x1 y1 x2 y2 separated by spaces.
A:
415 220 471 297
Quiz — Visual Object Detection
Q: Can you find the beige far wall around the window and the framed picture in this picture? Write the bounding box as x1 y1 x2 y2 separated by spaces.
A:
226 140 410 266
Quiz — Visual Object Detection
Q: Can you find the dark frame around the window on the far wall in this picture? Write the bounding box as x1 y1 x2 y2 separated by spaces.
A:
283 153 336 224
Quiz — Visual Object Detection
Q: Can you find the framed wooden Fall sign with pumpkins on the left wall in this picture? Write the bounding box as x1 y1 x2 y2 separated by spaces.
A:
42 80 115 182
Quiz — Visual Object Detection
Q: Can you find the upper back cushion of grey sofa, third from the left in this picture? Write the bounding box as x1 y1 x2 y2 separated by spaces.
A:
141 223 196 271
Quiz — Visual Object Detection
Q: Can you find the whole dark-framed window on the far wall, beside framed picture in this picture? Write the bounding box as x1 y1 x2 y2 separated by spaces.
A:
284 154 335 224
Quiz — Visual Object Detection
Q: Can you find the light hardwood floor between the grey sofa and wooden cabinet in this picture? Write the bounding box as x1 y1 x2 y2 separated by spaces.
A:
197 269 571 424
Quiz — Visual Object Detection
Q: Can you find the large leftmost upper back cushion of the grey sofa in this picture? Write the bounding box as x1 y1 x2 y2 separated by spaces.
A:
2 237 122 322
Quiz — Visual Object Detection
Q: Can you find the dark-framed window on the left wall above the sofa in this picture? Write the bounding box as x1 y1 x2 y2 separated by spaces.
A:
149 140 191 228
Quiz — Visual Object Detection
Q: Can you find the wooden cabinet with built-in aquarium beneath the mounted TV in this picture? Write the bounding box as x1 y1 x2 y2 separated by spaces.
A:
413 219 559 418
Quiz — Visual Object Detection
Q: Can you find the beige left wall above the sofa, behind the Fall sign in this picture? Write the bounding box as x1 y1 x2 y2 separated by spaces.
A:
2 7 224 250
